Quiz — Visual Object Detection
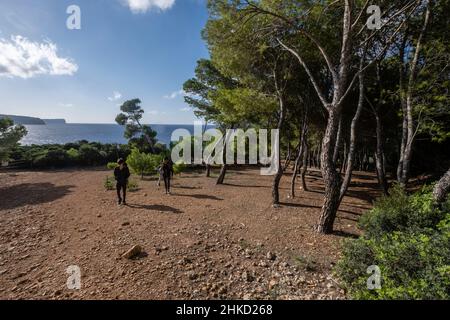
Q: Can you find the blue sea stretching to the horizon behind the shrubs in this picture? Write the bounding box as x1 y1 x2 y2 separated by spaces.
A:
20 123 209 145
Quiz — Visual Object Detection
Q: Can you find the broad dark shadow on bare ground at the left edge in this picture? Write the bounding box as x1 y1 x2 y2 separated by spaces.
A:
0 183 75 210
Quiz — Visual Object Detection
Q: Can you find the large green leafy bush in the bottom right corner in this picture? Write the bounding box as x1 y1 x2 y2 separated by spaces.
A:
335 188 450 299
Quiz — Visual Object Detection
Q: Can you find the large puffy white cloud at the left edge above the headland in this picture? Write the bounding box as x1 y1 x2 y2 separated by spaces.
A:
0 36 78 79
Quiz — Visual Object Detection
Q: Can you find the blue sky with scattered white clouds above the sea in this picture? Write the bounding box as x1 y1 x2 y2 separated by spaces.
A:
0 0 208 124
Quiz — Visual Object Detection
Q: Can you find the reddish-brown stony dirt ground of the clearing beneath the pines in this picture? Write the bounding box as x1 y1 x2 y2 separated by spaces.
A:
0 170 376 299
